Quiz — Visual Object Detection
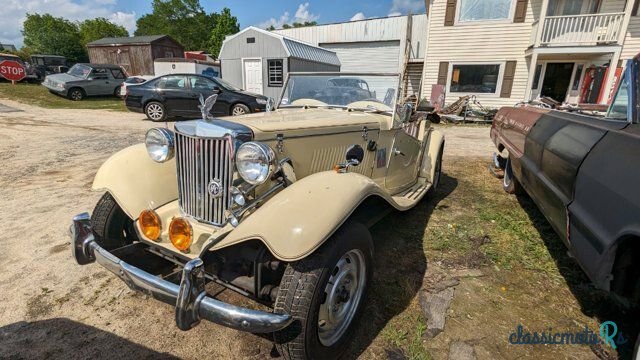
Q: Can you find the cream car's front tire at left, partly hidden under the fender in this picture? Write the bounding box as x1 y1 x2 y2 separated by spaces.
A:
91 193 137 250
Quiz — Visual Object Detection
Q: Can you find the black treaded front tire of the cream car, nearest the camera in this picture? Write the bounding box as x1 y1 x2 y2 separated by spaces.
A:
274 223 373 360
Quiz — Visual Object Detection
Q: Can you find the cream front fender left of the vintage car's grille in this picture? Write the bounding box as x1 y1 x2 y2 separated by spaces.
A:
92 144 178 220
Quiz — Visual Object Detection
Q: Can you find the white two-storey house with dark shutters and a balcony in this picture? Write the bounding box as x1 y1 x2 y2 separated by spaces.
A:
422 0 640 107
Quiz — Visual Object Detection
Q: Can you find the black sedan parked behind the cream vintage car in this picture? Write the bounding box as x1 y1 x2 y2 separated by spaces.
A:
125 74 268 121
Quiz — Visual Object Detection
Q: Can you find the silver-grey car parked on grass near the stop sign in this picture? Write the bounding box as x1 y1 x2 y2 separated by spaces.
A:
42 64 127 101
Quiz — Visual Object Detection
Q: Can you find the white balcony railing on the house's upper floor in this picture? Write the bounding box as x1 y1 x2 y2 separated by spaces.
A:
538 12 624 46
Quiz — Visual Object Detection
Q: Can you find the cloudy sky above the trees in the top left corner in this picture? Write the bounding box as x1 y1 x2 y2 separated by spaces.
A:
0 0 136 47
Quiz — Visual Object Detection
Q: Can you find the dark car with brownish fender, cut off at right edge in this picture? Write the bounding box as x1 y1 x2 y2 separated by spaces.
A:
491 57 640 304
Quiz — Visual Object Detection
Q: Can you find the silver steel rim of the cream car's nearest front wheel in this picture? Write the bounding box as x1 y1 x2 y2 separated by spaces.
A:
318 249 367 346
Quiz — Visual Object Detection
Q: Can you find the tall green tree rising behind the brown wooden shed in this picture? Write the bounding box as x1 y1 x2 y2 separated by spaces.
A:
135 0 216 50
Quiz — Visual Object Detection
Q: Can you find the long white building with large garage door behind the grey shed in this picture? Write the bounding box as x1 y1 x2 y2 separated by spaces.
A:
273 14 427 95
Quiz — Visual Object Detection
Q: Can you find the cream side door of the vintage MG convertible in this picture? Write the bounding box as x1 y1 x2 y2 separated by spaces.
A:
385 118 422 193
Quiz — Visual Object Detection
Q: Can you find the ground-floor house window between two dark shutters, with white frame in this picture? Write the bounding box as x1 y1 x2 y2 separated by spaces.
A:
449 64 500 94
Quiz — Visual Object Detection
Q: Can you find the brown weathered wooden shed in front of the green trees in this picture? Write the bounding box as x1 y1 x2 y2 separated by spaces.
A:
87 35 184 75
